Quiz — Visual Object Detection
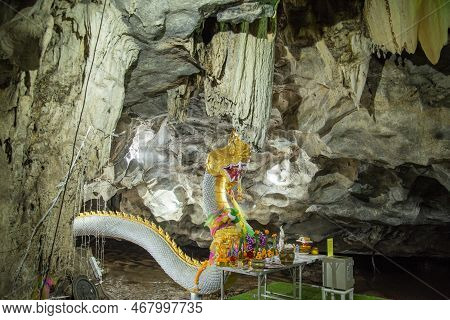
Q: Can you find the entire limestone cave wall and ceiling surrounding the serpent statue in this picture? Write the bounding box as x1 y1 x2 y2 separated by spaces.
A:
0 0 450 297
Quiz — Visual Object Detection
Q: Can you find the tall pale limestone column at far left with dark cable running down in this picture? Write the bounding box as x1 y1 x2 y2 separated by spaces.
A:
0 0 138 297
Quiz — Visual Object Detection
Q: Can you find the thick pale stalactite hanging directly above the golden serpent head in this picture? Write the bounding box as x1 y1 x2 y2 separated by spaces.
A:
198 17 276 147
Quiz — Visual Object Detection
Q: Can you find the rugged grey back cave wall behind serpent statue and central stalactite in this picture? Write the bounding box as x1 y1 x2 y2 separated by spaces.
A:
87 1 450 256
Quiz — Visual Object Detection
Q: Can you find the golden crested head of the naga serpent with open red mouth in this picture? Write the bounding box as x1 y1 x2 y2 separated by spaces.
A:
206 130 250 182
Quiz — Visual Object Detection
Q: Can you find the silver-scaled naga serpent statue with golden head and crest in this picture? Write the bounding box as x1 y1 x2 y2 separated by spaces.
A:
73 131 253 294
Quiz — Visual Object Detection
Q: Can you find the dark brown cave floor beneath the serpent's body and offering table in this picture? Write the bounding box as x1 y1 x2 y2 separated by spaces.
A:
99 239 450 300
